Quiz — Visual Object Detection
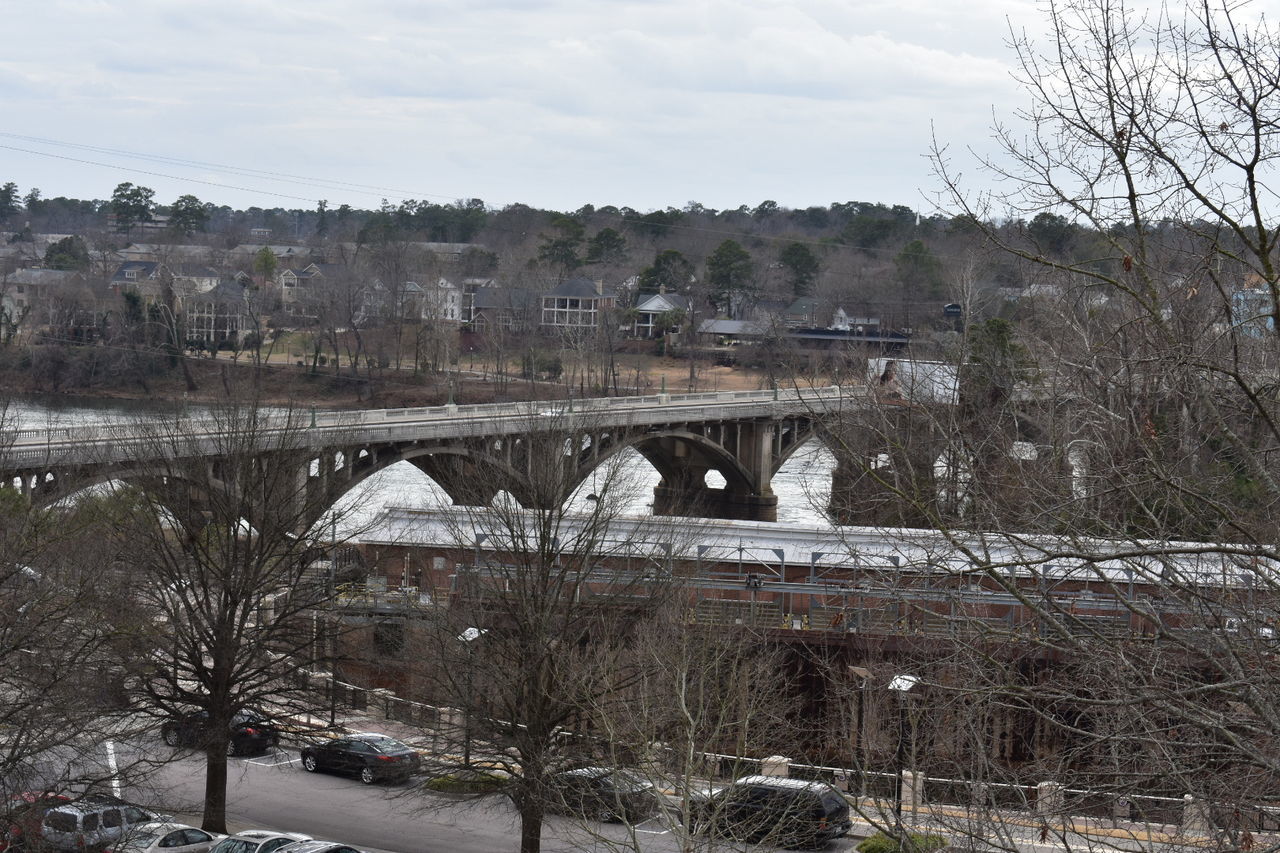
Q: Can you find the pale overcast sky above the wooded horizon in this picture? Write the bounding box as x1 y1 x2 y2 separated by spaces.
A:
0 0 1042 210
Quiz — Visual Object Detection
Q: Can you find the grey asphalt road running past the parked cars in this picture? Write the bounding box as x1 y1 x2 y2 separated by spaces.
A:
124 744 854 853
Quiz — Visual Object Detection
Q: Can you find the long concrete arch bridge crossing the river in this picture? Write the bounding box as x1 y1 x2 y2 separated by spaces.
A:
0 387 878 528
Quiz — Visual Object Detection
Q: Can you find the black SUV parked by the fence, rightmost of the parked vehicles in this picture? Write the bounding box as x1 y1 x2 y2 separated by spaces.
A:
691 776 852 848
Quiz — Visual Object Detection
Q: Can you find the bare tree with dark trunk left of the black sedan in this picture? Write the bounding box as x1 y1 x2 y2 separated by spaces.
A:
101 398 371 831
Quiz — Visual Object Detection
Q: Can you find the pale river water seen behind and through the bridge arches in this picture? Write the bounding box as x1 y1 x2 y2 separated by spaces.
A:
5 397 835 525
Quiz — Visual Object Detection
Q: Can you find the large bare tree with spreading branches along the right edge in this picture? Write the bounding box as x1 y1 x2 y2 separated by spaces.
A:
798 0 1280 849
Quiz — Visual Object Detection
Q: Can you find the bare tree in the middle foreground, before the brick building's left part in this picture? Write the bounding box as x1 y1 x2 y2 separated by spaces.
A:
389 406 675 853
